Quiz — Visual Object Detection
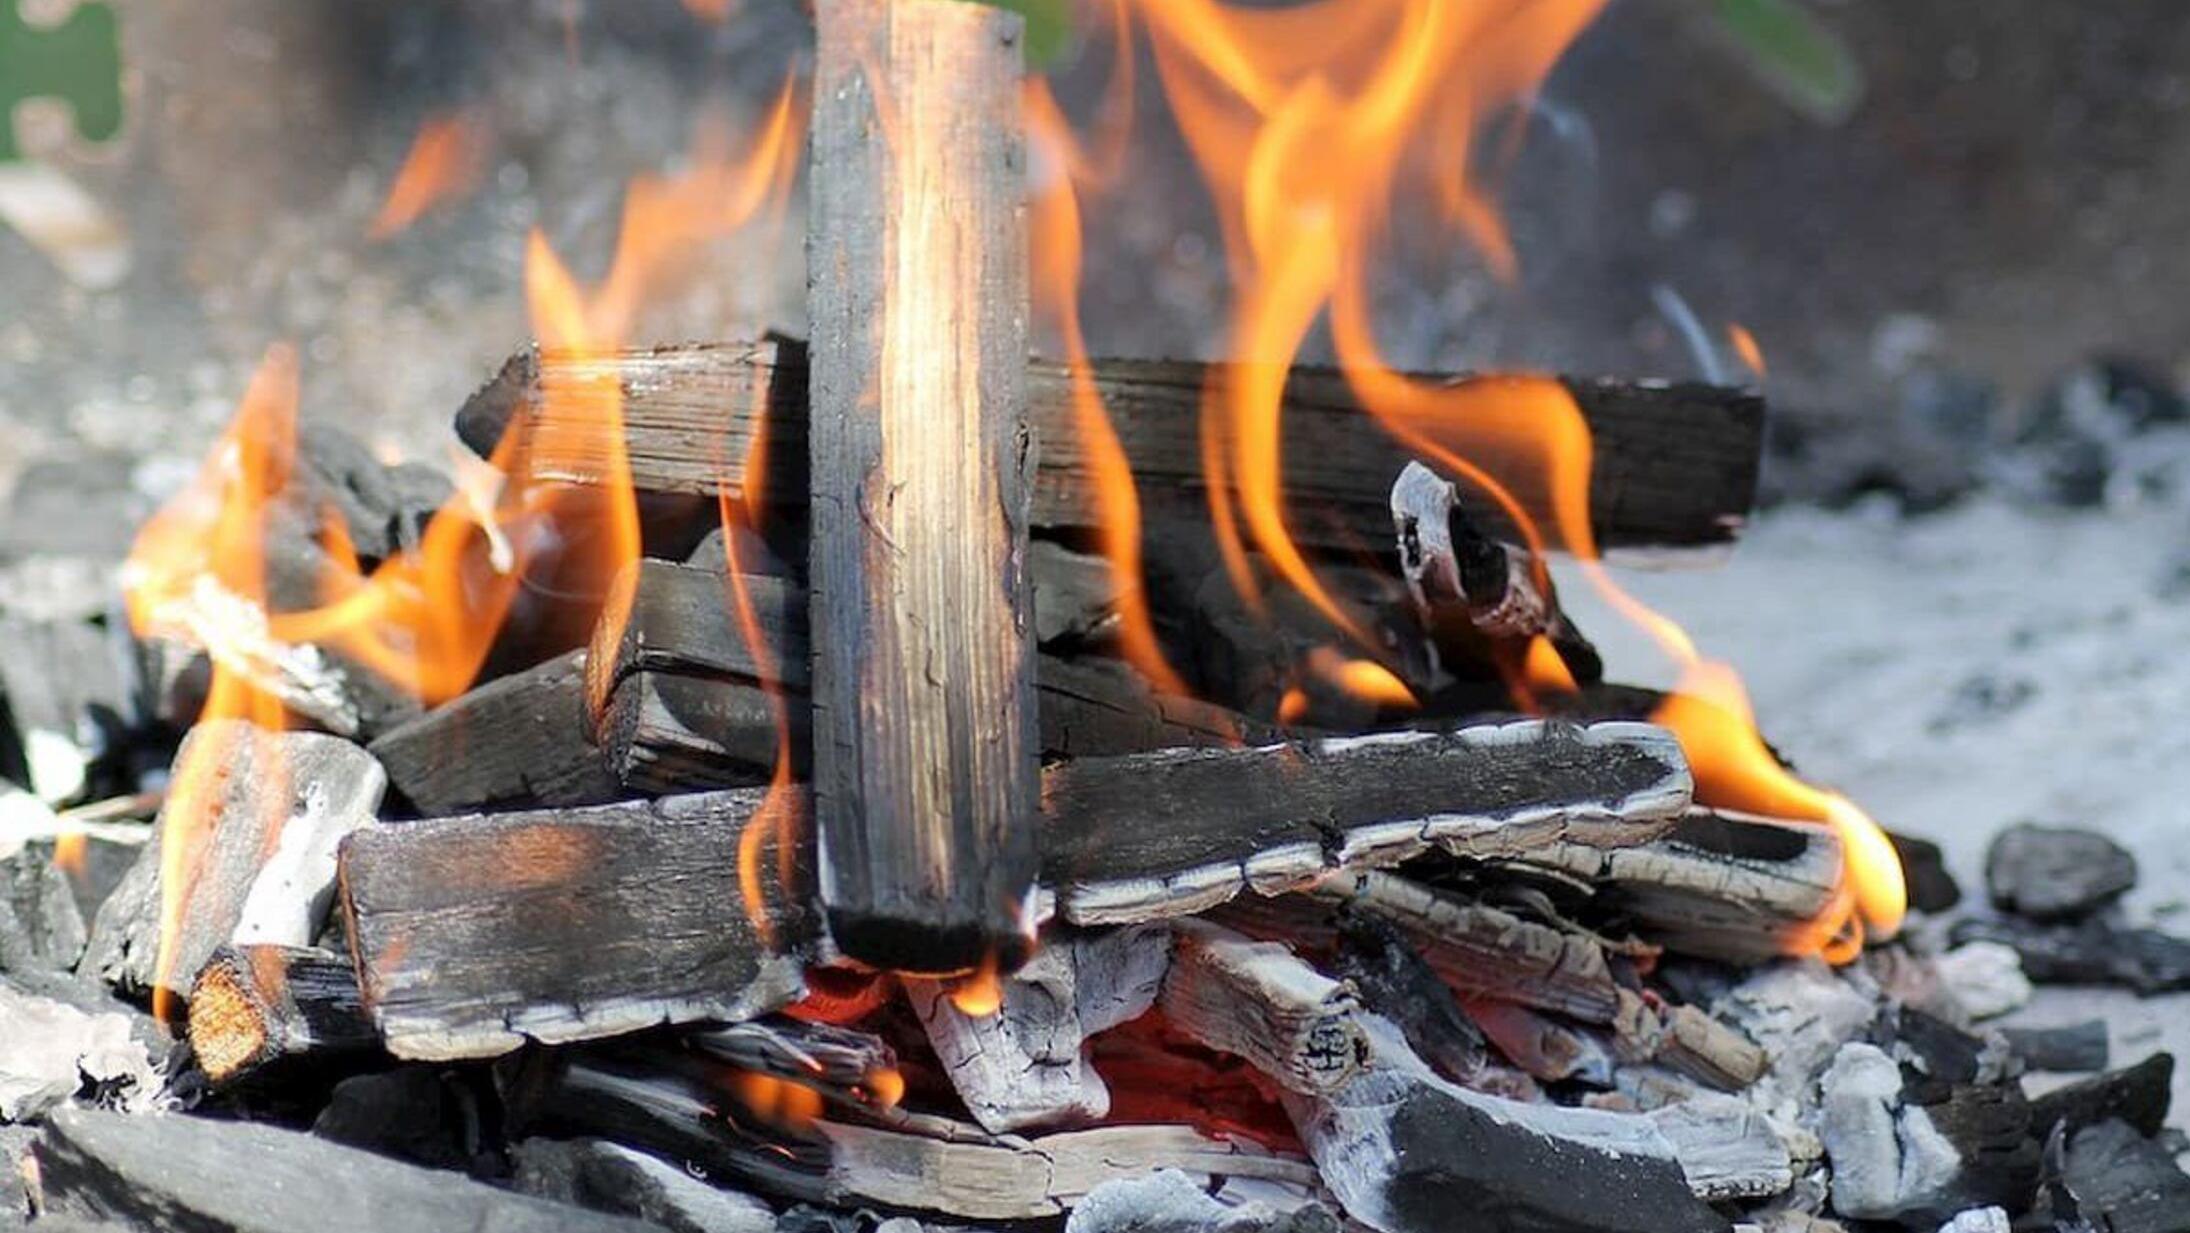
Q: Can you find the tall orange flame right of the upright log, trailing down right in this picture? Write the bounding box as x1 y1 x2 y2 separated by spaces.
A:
1077 0 1905 955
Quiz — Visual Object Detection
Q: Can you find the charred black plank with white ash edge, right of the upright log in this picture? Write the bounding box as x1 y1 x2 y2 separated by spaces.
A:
1042 721 1691 924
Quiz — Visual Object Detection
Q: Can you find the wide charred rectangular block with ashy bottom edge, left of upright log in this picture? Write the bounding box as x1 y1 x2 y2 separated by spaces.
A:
342 791 815 1060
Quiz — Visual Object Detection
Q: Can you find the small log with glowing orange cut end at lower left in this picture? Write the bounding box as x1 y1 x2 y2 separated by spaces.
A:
191 944 381 1084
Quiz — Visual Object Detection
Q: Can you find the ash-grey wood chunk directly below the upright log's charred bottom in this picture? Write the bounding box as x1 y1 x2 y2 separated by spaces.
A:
904 926 1172 1134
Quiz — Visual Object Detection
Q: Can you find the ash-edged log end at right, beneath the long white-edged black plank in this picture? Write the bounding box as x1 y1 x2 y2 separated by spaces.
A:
1515 808 1842 964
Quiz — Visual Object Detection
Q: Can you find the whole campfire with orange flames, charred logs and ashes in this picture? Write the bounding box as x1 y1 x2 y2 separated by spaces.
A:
0 0 2190 1233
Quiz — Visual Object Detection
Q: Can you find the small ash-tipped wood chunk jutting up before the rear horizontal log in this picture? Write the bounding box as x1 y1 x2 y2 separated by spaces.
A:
1391 462 1605 683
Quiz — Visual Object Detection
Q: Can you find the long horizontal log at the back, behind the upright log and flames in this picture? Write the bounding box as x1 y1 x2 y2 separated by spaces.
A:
456 339 1765 550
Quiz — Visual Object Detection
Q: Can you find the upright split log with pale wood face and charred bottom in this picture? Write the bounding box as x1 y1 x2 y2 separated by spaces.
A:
805 0 1040 972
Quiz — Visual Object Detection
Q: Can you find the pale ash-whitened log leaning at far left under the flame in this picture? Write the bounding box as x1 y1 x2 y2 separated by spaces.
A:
83 721 388 996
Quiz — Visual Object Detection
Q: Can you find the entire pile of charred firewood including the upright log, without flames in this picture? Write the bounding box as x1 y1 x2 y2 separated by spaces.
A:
0 0 2166 1233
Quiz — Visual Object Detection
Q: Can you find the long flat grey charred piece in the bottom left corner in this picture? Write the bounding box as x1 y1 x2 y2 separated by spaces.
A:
37 1108 650 1233
